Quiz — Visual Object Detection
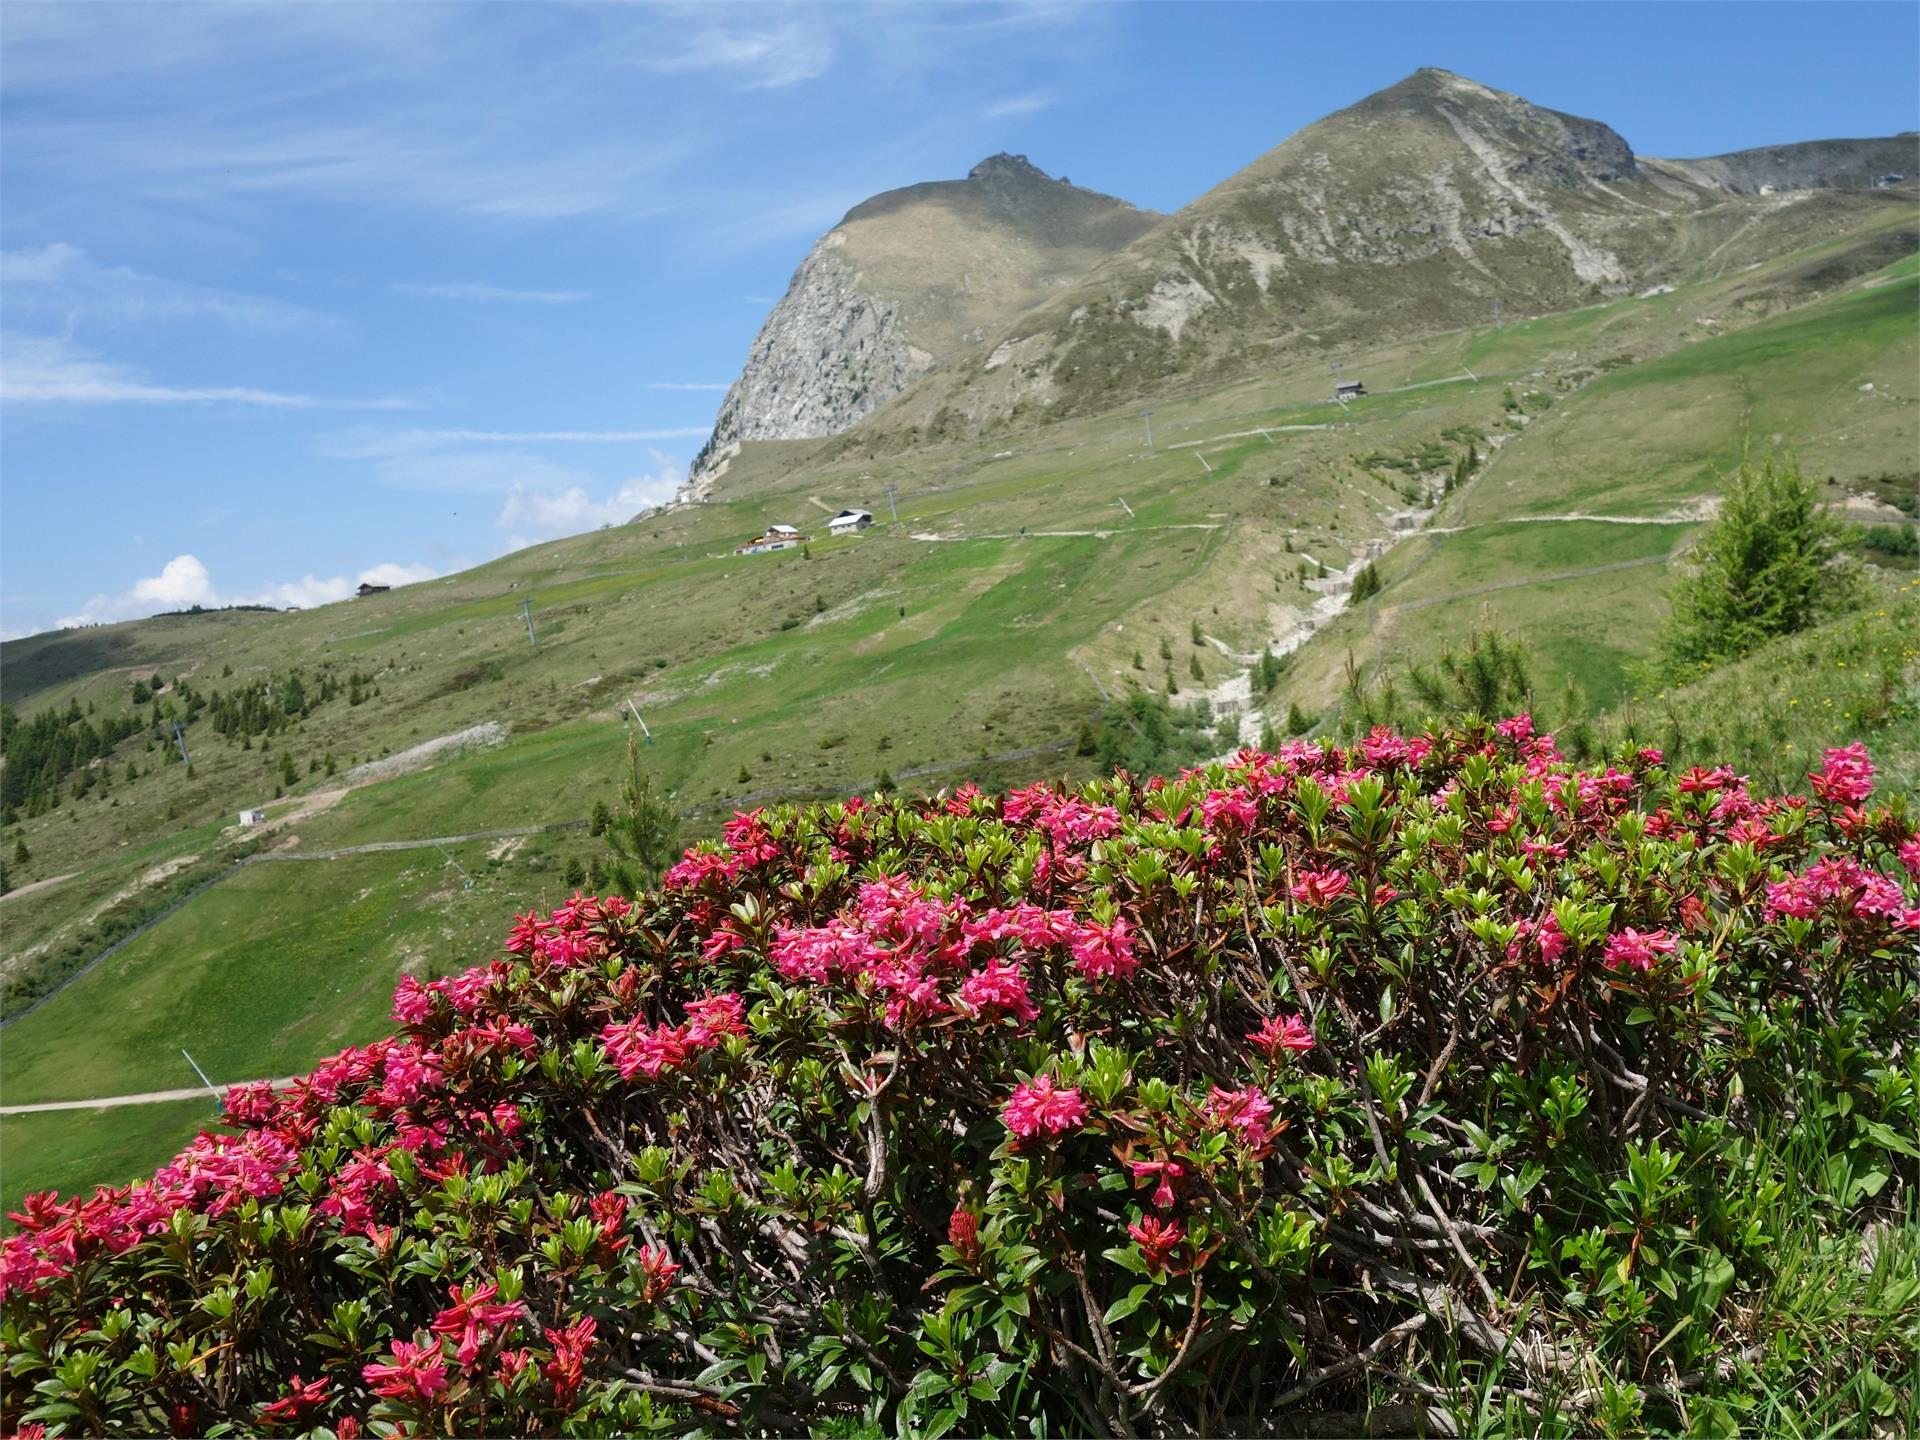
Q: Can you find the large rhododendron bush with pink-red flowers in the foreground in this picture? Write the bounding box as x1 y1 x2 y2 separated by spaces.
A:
0 733 1920 1436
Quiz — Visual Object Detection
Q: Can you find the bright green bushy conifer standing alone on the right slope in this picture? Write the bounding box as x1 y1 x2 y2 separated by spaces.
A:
1661 455 1862 678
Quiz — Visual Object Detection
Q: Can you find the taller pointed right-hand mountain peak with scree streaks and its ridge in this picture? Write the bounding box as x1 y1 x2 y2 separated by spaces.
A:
849 69 1916 447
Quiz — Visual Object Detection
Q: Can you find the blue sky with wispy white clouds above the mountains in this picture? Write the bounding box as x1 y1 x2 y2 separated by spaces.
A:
0 0 1920 636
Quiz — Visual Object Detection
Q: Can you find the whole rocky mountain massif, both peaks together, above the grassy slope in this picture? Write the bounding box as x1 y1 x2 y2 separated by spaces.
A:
672 69 1920 495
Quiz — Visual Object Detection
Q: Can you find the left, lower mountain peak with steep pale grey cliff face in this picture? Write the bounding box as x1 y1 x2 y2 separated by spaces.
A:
684 154 1158 499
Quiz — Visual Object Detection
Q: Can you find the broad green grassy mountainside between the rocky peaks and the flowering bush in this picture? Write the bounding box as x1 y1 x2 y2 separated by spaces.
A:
0 194 1920 1205
